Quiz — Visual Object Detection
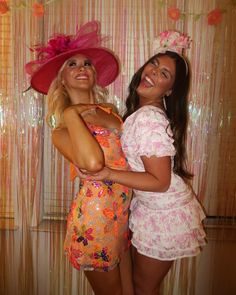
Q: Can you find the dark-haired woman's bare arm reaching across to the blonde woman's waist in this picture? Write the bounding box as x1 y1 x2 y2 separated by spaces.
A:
80 156 171 192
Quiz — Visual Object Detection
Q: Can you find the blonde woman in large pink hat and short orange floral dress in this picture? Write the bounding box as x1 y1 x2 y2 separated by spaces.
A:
26 22 133 295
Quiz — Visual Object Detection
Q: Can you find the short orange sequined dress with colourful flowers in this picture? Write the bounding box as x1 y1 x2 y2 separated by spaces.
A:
64 110 131 271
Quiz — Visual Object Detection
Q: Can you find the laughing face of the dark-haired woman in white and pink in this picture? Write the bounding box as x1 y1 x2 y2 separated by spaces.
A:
137 55 175 104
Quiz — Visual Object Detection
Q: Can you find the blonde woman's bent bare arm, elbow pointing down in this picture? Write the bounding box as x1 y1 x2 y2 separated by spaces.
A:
52 107 104 172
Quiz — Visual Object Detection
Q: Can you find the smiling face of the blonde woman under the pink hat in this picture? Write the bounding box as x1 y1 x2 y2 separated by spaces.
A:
61 54 95 90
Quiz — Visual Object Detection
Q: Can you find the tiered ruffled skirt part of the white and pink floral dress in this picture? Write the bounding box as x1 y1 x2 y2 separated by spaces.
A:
129 197 206 260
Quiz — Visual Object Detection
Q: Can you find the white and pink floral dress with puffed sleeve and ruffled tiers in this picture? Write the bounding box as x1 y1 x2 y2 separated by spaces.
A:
121 106 205 260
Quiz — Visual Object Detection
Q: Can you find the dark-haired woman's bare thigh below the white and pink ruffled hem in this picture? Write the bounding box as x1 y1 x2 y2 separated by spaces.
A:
132 247 173 295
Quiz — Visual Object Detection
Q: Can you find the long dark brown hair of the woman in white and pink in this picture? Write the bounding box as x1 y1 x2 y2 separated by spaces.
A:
123 51 193 180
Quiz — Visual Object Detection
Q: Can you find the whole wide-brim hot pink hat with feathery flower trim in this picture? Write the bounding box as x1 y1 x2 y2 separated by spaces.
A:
25 21 119 94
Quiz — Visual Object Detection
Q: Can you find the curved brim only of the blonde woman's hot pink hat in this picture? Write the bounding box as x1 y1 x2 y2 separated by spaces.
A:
30 47 119 94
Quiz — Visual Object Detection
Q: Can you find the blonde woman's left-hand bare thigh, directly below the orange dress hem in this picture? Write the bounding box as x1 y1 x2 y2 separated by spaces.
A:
85 267 122 295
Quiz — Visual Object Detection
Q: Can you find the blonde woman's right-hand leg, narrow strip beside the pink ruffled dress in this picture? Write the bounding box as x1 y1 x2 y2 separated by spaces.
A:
120 249 134 295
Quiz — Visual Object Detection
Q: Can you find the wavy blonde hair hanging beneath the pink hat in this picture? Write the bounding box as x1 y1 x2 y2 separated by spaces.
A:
46 62 108 128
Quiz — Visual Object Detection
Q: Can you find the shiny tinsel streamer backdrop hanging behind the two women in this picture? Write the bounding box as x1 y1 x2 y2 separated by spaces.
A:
0 0 236 295
